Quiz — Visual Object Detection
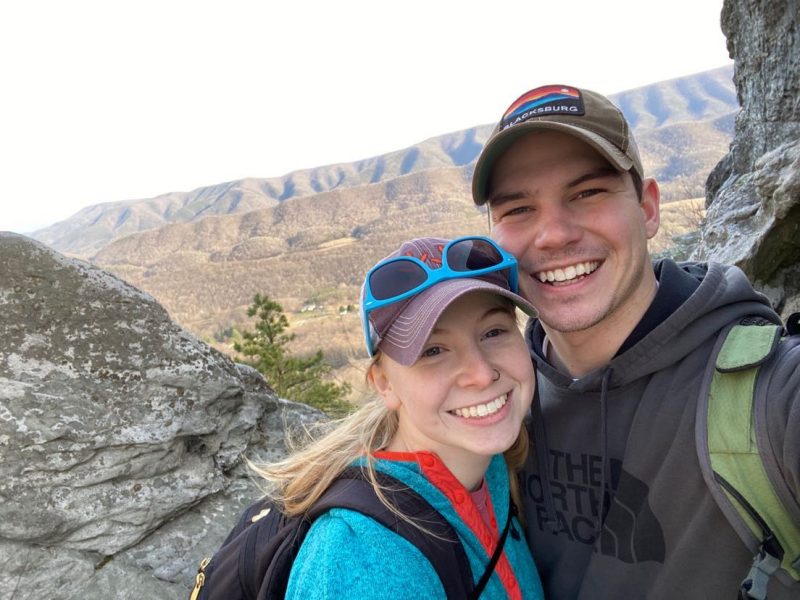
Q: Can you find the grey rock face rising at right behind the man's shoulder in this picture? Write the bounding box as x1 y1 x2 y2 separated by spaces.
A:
694 0 800 317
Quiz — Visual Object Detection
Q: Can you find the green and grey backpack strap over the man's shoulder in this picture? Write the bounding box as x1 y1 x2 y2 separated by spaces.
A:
695 314 800 600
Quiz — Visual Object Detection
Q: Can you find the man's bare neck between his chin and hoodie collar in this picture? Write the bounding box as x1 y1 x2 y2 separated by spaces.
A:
542 271 658 379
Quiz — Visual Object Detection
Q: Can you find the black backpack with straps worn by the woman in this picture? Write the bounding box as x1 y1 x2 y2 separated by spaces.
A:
190 467 515 600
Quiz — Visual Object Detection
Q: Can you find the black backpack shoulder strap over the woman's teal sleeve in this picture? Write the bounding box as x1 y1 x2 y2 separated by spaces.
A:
308 467 474 600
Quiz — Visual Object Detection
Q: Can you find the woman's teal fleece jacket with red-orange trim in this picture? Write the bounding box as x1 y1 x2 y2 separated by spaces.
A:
286 452 543 600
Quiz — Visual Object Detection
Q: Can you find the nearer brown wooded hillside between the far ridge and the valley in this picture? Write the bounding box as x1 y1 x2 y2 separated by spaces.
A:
94 168 487 335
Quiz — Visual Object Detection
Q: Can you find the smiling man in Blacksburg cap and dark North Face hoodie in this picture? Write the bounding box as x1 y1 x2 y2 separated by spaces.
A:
473 86 800 600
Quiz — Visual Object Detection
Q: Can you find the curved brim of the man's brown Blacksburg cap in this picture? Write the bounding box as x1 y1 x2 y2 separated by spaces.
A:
472 120 634 206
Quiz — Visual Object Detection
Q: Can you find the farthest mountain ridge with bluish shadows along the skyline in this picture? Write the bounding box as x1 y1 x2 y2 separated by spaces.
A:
33 67 738 257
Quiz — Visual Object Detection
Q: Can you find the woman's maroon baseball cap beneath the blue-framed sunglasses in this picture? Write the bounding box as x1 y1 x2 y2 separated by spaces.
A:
361 238 536 366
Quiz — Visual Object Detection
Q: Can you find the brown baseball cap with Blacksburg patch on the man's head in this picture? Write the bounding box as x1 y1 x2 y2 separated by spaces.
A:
472 85 644 205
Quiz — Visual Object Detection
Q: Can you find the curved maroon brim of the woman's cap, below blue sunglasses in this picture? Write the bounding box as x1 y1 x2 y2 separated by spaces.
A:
378 278 536 366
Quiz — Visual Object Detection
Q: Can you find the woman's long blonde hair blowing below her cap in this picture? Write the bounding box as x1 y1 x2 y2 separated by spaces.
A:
250 302 528 522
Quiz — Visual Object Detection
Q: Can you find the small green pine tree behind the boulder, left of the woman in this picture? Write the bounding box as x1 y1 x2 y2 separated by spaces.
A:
233 294 353 417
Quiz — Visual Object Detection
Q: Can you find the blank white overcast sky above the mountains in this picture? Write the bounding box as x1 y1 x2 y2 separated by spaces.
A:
0 0 731 233
